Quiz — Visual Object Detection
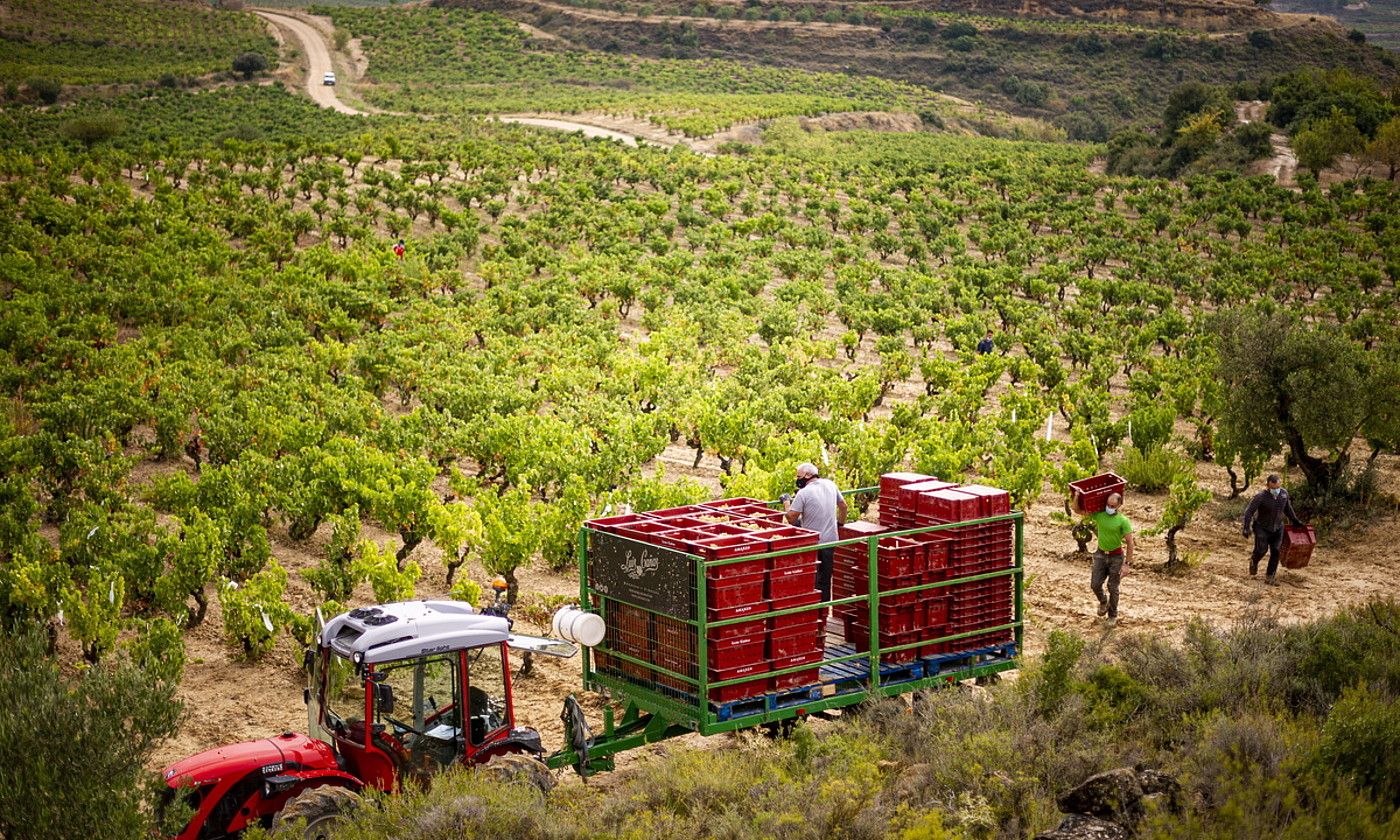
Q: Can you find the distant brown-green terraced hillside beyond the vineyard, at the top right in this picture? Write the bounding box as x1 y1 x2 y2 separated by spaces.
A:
440 0 1397 140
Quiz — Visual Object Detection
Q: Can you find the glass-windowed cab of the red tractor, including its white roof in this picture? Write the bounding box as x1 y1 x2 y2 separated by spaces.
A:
307 601 543 790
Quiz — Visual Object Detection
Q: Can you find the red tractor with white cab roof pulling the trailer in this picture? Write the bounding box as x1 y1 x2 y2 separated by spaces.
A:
165 601 575 840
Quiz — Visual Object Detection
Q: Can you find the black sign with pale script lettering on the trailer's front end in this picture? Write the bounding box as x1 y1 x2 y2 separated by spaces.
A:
588 531 696 619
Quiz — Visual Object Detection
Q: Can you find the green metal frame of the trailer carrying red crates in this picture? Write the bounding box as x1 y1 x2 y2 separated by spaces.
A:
546 487 1025 776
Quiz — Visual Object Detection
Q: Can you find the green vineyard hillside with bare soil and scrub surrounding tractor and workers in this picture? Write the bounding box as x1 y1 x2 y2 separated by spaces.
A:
0 0 1400 840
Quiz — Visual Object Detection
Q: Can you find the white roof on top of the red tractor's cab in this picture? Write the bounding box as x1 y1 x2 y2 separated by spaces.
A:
321 601 510 664
